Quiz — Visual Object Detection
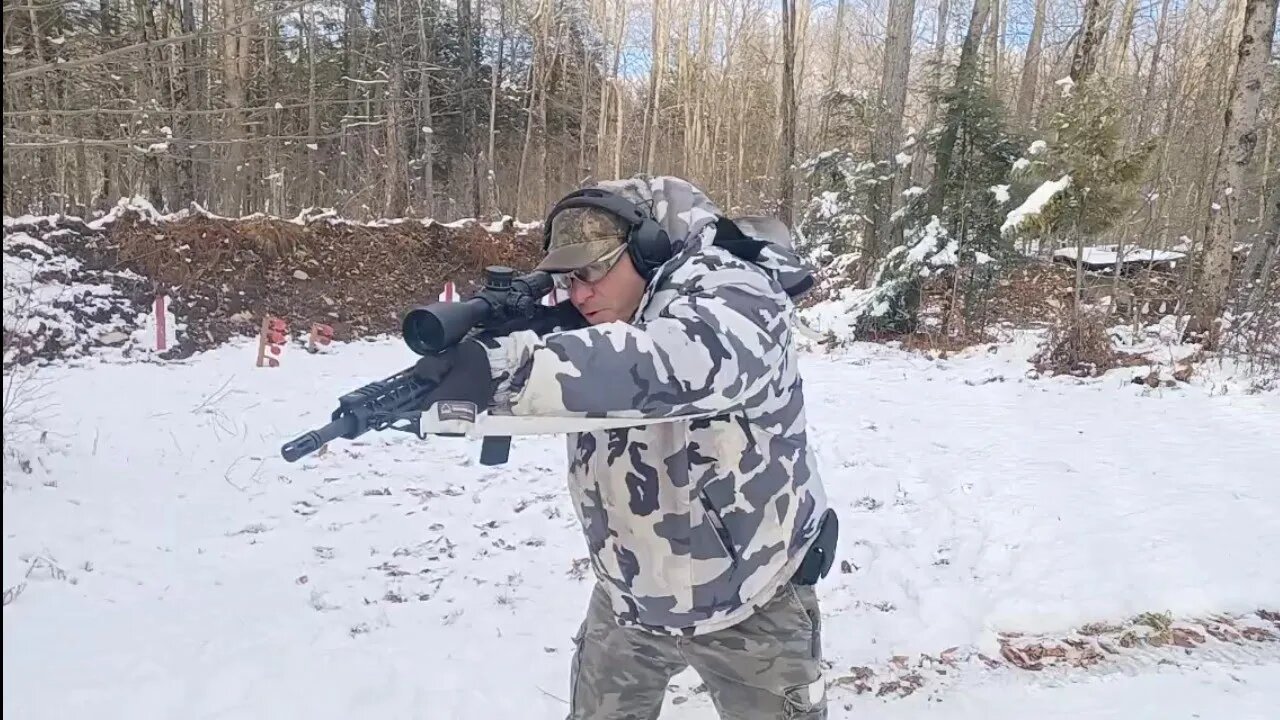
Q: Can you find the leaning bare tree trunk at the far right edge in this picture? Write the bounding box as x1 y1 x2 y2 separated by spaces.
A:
1194 0 1277 345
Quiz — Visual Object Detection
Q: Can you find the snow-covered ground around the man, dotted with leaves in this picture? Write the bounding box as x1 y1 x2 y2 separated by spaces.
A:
4 340 1280 720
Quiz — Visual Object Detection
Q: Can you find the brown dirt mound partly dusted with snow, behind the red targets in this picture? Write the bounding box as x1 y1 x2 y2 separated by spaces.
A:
4 202 540 365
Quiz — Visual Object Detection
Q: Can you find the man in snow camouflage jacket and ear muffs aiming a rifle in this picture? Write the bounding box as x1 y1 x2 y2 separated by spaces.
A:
415 177 836 720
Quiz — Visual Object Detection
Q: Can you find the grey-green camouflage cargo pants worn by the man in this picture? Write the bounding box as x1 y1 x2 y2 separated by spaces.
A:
568 576 827 720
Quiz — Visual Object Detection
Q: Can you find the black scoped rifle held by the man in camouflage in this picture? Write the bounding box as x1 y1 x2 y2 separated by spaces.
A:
280 265 582 465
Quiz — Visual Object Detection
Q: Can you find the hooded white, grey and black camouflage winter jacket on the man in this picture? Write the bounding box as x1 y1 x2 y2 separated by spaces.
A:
489 178 826 634
